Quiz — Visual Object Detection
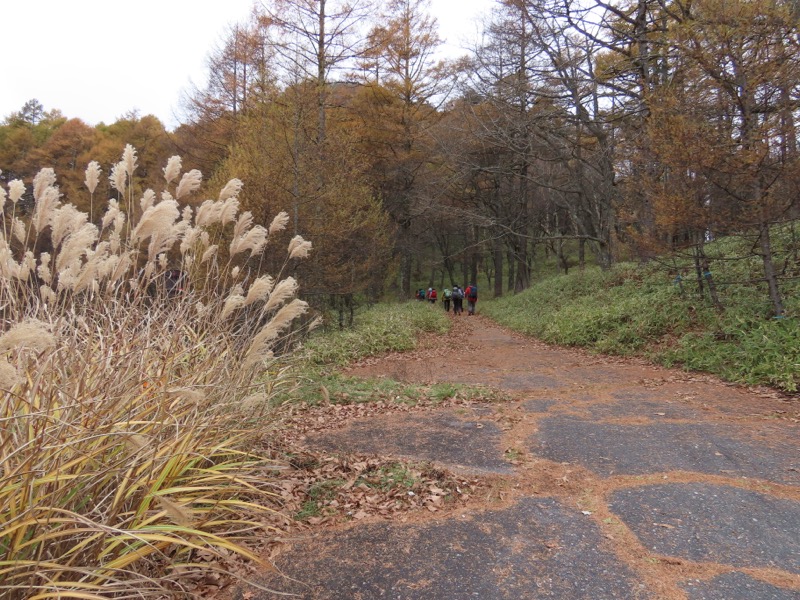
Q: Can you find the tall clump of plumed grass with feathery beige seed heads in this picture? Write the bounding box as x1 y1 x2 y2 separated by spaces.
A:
0 146 310 599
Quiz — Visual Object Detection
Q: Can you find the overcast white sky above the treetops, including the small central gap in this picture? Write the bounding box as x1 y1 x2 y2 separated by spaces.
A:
0 0 494 128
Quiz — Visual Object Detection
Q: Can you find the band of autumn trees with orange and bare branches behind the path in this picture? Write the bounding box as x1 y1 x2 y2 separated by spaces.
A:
0 0 800 317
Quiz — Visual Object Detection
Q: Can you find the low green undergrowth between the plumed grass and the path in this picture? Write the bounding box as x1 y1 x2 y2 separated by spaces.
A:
284 302 497 406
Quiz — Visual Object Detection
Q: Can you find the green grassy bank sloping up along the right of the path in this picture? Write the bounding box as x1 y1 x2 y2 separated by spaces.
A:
481 230 800 392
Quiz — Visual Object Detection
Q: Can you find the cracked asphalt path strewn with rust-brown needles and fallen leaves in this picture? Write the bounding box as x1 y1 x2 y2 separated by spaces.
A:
233 315 800 600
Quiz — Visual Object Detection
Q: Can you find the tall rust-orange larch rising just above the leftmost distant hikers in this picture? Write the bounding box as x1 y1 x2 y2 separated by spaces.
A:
357 0 450 297
